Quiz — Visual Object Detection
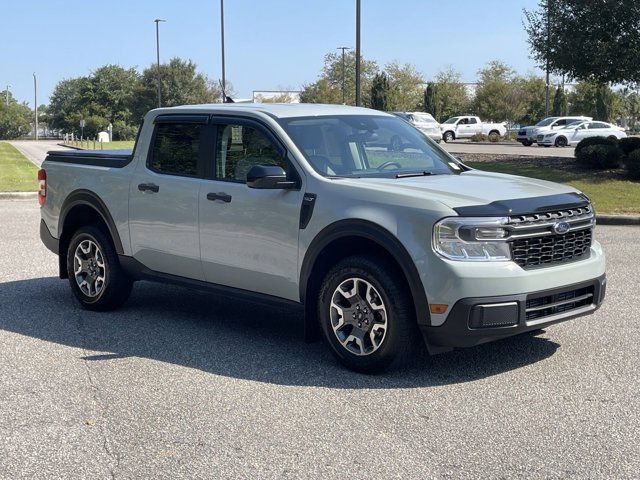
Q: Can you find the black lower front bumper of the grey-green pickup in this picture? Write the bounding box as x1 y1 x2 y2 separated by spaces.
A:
420 275 607 353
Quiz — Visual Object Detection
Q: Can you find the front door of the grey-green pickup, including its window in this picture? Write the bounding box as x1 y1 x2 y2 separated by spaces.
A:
198 119 303 300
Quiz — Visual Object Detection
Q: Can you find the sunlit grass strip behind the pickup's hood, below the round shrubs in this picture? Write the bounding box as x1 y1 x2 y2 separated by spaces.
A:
465 160 640 215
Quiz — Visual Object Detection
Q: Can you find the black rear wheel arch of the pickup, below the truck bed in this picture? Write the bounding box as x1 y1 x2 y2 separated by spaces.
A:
58 189 124 278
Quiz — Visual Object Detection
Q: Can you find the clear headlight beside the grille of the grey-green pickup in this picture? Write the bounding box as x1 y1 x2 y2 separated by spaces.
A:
433 217 511 262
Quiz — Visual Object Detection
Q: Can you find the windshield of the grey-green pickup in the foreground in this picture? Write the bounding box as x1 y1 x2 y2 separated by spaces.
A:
279 115 459 177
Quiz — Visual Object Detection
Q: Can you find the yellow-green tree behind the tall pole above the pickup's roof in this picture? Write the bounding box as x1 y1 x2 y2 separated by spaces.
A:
300 51 378 106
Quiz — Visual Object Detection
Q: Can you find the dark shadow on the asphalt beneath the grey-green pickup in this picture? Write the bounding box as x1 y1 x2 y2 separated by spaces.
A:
0 277 559 388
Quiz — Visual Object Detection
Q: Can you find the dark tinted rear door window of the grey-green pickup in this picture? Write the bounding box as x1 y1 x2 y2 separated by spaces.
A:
149 123 205 177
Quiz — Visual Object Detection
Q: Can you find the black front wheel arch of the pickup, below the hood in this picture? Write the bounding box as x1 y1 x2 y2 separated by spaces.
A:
299 220 430 340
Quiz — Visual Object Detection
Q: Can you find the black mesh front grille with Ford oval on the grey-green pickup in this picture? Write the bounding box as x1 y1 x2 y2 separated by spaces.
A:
506 206 595 268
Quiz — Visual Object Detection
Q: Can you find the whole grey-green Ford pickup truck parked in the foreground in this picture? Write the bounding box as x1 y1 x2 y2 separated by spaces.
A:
39 104 606 371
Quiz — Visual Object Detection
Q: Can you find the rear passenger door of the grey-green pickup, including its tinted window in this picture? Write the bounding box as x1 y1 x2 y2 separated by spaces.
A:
129 115 212 280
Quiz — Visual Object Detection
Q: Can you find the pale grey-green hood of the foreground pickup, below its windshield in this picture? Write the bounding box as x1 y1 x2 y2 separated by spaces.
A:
339 170 580 209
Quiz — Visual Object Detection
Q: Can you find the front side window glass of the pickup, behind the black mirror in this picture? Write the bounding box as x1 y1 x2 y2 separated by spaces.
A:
216 124 287 182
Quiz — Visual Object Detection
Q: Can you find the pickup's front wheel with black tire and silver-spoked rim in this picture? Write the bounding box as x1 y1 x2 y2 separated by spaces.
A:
318 256 420 373
